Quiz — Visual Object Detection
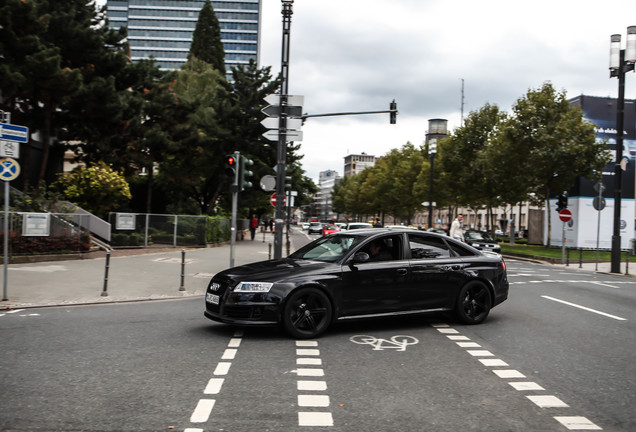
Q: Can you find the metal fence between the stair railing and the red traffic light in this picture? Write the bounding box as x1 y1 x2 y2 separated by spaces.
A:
108 213 249 247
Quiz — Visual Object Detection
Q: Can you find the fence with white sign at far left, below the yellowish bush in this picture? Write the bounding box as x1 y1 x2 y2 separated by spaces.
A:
0 212 91 256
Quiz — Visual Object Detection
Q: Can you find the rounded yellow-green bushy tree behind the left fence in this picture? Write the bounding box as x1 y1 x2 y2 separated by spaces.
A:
52 162 131 217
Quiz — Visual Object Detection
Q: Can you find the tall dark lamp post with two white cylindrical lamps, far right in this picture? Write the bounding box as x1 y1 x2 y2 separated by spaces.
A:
610 26 636 273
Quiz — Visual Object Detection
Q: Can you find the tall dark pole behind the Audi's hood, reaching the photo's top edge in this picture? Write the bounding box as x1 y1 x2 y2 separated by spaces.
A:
274 0 294 259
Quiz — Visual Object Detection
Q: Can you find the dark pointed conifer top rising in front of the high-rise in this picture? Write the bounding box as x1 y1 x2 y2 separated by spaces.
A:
188 0 225 75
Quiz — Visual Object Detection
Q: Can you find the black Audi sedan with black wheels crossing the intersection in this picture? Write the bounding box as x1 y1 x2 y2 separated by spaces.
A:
205 228 508 339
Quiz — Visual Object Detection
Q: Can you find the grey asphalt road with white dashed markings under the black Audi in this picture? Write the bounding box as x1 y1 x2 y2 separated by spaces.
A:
0 246 636 432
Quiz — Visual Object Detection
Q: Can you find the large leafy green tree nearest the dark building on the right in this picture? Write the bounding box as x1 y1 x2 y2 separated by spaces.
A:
489 82 610 246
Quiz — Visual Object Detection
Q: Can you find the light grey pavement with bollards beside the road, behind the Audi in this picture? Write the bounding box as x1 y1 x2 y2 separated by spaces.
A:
0 232 636 313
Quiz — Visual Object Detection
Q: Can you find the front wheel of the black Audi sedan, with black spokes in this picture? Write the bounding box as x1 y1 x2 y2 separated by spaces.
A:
283 288 333 339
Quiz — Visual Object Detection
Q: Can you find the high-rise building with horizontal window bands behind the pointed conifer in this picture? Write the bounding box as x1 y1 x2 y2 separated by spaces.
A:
106 0 261 71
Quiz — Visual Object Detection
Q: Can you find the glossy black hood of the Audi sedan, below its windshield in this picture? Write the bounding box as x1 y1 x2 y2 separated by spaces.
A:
217 258 328 282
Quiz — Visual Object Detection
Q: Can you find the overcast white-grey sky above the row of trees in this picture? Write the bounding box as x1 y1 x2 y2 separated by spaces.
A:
260 0 636 182
